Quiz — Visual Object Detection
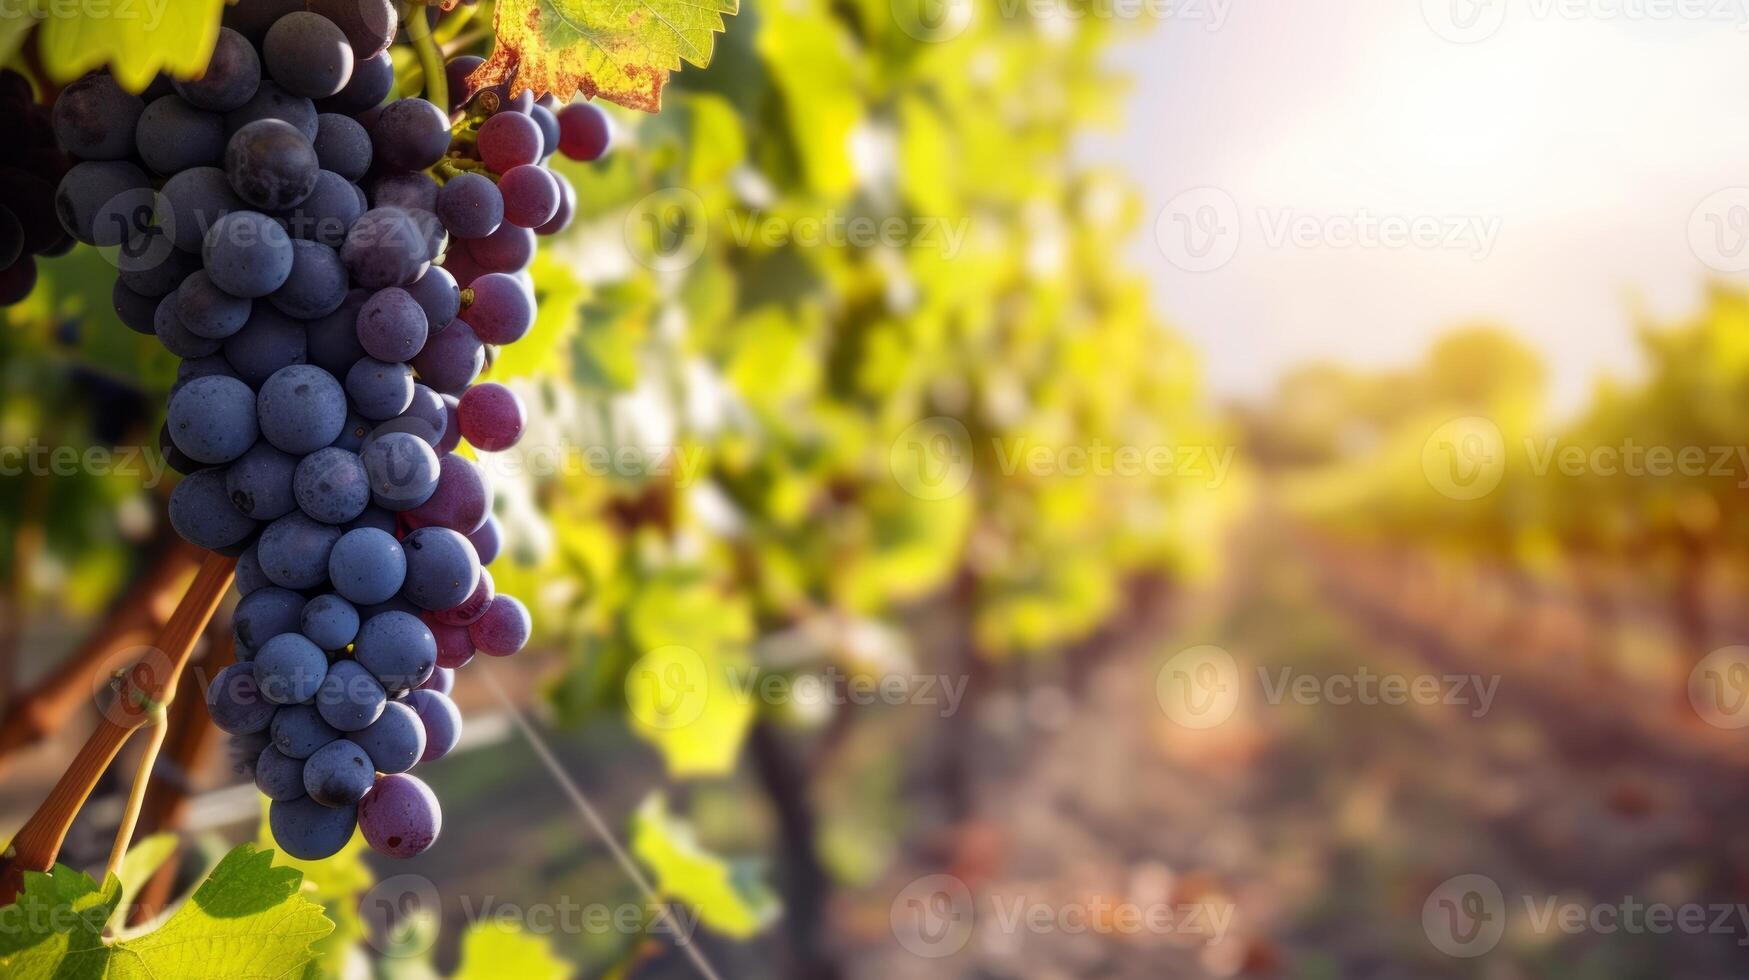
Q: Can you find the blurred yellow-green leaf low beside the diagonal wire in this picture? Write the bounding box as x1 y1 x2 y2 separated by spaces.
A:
631 793 780 940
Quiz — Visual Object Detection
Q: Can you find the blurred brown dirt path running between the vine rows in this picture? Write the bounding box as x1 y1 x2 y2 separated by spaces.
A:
850 525 1749 978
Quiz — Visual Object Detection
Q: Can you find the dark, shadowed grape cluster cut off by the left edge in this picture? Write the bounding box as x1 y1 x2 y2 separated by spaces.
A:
0 68 73 306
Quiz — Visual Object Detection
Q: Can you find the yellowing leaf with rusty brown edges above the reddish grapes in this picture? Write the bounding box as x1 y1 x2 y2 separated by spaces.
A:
469 0 740 112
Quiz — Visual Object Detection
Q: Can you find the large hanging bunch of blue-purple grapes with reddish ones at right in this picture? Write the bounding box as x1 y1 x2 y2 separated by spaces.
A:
46 0 609 859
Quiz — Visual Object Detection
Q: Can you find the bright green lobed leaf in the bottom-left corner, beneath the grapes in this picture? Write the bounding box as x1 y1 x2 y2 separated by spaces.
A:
0 844 334 980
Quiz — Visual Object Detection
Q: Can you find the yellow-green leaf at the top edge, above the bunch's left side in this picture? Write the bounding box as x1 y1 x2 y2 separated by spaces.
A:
33 0 224 93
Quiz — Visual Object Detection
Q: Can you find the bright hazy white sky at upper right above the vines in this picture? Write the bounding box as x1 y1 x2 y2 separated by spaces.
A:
1088 0 1749 411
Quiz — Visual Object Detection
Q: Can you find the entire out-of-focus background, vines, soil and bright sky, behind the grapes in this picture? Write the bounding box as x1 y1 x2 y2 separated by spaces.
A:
0 0 1749 980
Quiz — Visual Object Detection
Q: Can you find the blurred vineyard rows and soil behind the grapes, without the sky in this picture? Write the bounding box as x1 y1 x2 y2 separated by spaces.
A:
0 0 1749 978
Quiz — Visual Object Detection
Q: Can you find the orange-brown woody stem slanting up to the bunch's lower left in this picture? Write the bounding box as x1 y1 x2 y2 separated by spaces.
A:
0 555 236 905
